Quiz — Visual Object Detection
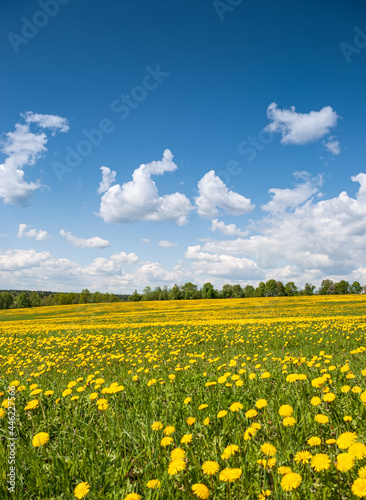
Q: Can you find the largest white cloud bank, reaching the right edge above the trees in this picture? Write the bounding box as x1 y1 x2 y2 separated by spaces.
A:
203 173 366 279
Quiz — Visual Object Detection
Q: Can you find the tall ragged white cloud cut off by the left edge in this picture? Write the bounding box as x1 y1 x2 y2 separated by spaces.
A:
0 111 68 205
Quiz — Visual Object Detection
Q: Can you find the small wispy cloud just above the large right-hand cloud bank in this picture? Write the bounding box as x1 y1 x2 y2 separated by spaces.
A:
261 172 322 213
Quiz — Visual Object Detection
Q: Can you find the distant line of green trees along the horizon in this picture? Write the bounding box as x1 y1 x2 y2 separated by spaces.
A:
0 279 366 309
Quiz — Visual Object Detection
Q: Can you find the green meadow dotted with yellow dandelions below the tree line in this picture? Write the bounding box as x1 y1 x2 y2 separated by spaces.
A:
0 295 366 500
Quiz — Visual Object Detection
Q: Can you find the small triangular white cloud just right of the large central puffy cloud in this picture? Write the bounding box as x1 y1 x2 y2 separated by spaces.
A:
195 170 254 217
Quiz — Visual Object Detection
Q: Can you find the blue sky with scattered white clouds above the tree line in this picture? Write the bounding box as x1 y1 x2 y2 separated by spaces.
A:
0 0 366 293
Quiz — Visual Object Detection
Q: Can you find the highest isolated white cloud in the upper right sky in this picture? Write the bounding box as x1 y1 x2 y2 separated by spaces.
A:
265 102 339 144
